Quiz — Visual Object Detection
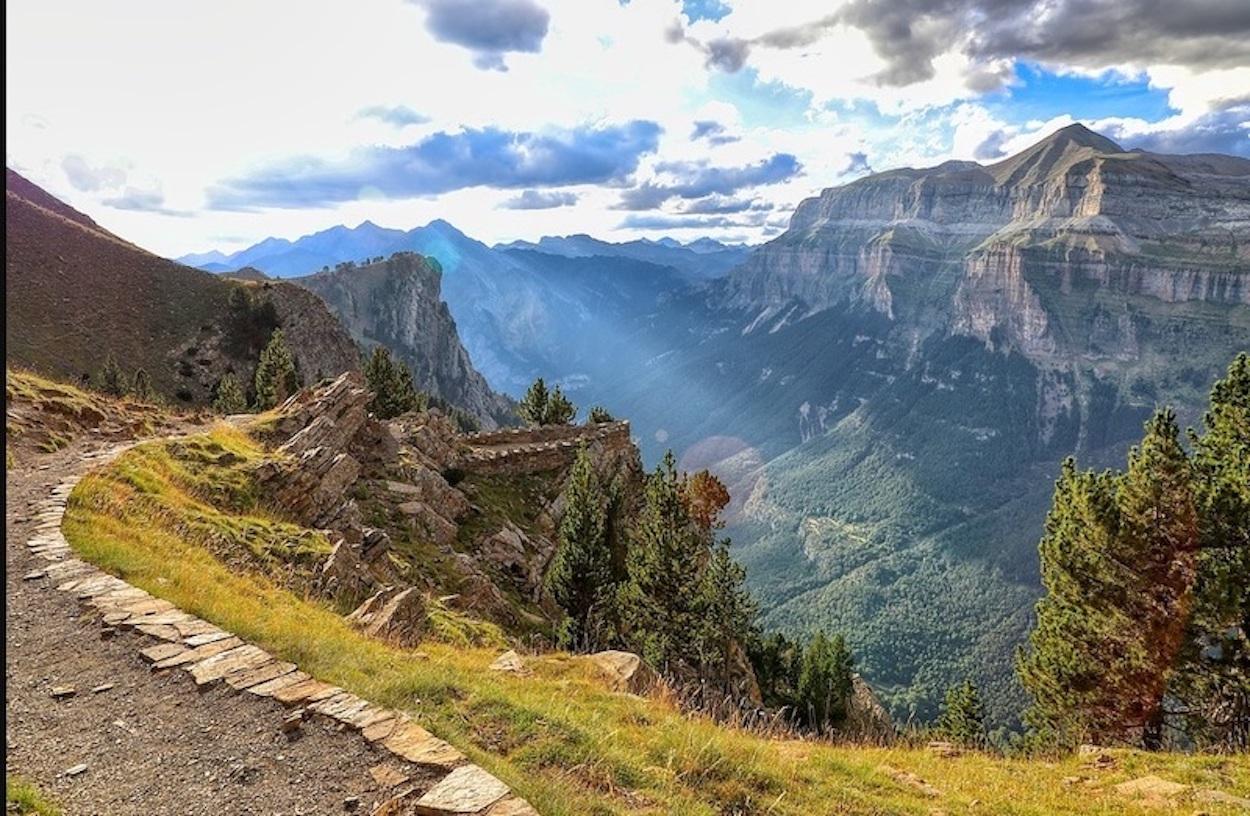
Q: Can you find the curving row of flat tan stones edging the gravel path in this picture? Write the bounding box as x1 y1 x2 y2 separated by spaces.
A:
25 444 538 816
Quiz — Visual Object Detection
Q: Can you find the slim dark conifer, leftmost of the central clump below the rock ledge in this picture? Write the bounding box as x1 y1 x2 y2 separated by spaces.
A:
545 447 614 651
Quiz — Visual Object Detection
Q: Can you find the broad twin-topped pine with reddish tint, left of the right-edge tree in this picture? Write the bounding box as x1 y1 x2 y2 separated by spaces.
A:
1019 411 1198 746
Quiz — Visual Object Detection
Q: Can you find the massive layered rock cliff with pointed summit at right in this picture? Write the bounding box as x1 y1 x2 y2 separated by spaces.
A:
725 125 1250 360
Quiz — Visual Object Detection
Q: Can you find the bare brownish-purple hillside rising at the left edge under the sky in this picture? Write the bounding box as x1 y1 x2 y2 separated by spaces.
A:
5 170 359 404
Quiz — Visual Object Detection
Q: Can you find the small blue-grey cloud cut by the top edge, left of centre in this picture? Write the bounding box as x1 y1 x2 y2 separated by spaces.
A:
414 0 551 71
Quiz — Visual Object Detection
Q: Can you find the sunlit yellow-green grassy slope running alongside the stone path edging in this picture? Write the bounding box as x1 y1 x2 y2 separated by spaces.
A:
58 429 1250 816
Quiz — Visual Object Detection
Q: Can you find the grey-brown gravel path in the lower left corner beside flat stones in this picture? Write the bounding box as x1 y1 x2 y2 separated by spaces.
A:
5 437 420 816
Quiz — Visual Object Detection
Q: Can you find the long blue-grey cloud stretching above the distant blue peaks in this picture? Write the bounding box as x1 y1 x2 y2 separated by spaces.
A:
208 120 661 210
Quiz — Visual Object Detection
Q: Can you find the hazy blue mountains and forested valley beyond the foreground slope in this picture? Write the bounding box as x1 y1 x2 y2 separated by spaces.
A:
31 126 1250 724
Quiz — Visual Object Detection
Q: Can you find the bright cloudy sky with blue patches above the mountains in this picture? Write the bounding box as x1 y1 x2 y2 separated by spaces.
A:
5 0 1250 256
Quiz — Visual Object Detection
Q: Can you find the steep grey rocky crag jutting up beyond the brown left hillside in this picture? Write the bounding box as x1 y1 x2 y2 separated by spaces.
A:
294 252 511 427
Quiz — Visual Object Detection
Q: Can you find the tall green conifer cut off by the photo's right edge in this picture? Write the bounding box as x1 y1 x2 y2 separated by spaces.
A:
1173 354 1250 751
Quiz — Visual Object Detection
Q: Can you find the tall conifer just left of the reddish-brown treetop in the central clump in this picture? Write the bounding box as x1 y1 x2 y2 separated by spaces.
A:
620 451 708 674
